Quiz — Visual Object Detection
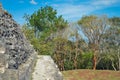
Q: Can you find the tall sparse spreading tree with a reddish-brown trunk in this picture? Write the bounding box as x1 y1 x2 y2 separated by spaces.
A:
78 15 109 70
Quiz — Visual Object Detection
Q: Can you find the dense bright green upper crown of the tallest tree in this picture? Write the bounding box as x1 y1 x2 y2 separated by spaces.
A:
29 6 57 31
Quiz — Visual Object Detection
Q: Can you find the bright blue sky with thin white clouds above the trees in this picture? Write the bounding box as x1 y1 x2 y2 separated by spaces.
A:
0 0 120 25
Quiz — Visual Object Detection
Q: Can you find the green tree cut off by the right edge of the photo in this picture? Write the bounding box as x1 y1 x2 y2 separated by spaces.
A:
101 17 120 70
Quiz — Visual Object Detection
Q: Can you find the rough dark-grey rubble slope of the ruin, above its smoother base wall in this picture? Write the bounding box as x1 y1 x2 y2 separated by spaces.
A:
0 4 34 69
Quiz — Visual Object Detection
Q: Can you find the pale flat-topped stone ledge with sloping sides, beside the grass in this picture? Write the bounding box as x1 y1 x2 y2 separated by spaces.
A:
32 56 63 80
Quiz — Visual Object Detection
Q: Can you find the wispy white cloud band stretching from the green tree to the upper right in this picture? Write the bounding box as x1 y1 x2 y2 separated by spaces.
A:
52 0 118 21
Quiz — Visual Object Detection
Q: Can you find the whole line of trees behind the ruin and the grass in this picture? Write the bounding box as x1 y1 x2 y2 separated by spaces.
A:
22 6 120 71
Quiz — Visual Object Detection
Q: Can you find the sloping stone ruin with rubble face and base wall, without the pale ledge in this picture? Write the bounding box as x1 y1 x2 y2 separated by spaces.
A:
0 4 36 80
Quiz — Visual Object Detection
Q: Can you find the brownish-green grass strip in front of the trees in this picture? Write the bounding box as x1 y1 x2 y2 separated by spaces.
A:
62 69 120 80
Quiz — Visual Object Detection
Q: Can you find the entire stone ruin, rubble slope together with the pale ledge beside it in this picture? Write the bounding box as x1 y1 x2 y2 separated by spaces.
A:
0 4 63 80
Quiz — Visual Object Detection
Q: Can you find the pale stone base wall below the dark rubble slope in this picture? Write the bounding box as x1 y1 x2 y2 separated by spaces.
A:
0 47 37 80
